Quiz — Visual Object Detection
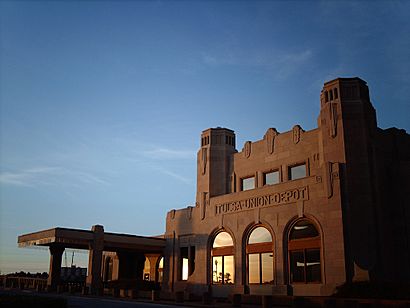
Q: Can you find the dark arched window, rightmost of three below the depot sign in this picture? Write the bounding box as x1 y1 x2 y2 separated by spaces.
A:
288 219 322 283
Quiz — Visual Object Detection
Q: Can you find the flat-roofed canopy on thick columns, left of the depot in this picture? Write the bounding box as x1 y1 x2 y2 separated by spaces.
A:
18 225 165 294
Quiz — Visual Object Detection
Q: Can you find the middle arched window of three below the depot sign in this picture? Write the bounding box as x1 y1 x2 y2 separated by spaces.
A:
246 227 273 284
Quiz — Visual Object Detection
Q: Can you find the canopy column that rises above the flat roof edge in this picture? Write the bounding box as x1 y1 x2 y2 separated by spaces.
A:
86 225 104 295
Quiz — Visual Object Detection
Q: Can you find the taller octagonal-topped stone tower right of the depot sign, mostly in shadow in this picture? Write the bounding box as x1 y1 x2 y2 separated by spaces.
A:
318 78 378 280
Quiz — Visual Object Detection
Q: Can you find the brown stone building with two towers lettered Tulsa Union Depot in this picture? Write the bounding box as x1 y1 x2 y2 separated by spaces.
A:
18 78 410 296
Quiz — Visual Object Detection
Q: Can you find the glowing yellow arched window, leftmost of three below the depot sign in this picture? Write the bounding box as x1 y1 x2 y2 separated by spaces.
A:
212 232 235 284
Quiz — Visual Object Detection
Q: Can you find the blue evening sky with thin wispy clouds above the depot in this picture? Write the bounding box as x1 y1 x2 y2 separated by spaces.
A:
0 1 410 273
